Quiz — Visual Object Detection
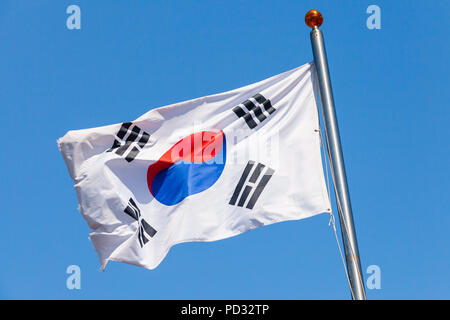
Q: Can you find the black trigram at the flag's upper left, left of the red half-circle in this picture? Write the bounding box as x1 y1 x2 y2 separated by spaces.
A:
107 122 150 162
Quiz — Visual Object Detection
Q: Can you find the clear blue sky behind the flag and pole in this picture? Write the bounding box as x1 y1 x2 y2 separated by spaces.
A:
0 0 450 299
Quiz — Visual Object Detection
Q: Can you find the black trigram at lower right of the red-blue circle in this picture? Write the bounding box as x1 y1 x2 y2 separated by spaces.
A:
229 161 275 209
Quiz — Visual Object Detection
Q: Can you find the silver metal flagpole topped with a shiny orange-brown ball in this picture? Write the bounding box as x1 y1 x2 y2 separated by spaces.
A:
305 10 366 300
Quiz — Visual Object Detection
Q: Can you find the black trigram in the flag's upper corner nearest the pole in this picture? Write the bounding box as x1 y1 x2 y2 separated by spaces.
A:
233 93 276 129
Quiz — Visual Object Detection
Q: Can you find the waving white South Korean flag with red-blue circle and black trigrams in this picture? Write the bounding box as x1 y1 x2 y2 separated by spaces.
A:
58 63 330 269
